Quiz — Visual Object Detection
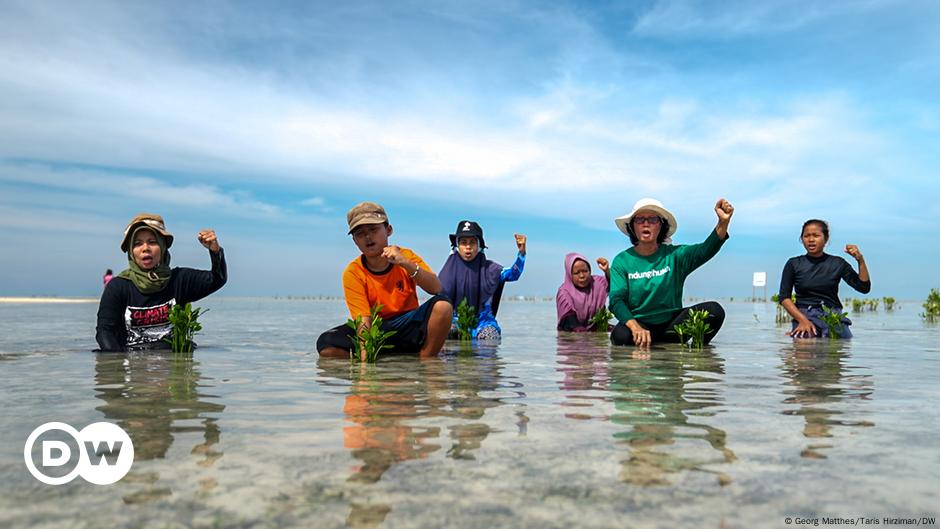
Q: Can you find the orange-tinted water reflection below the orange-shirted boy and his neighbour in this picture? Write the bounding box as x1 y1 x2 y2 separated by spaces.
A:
317 350 514 527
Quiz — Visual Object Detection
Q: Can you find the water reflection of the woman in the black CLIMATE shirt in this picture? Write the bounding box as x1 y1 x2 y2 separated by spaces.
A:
95 353 225 503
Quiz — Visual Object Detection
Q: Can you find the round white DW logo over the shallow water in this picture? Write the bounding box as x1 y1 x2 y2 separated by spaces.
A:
23 422 134 485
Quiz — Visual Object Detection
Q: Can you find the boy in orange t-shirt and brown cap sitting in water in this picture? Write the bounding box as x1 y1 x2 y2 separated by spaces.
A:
317 202 454 357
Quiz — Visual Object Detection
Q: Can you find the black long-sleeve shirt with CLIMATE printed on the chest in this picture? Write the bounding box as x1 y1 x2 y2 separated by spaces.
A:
95 249 228 351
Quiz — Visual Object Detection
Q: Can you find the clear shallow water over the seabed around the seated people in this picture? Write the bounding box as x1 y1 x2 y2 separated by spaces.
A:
0 298 940 528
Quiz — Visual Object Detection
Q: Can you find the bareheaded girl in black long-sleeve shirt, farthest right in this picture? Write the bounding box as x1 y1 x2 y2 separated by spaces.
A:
780 219 871 338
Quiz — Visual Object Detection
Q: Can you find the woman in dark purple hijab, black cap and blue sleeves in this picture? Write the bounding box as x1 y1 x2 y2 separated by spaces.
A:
440 220 526 340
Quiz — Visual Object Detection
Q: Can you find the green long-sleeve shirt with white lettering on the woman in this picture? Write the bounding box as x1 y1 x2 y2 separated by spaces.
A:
610 230 727 325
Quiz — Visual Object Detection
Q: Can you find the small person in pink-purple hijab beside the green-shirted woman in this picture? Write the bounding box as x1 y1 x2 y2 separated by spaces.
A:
555 253 610 332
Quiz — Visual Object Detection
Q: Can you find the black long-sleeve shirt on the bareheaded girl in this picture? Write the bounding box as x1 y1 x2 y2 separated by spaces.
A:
780 254 871 311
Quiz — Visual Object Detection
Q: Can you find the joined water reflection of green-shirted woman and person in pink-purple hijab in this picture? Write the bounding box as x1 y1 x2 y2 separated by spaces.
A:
558 335 735 486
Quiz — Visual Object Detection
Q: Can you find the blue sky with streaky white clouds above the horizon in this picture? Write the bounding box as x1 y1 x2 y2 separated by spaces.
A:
0 0 940 299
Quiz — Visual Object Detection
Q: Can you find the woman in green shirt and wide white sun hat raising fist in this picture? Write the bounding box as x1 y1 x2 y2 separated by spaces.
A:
610 198 734 346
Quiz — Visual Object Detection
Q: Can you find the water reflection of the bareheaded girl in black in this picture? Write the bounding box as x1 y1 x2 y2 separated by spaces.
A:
781 340 874 459
